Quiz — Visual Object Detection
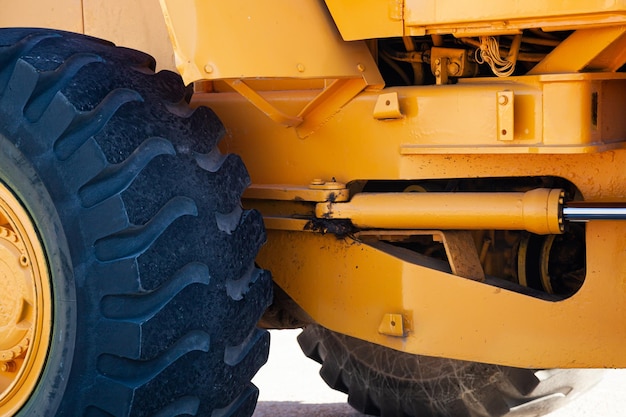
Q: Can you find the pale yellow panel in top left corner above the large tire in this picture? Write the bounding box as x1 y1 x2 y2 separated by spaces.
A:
0 0 83 33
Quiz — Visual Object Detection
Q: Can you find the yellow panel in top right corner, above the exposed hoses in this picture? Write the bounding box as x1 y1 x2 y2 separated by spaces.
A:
325 0 626 40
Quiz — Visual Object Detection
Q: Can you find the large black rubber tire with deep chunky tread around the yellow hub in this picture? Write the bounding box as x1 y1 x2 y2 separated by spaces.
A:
0 29 272 417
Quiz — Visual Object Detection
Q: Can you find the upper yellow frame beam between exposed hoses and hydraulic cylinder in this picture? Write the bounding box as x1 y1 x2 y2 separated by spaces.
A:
194 73 626 188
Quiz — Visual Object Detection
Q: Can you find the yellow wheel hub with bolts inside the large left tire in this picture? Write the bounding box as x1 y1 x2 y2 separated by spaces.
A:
0 183 52 416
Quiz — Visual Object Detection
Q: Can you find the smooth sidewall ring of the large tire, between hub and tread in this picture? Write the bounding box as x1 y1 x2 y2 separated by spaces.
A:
0 134 76 417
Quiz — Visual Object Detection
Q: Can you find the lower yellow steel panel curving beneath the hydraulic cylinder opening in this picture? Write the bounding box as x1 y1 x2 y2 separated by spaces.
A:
259 221 626 368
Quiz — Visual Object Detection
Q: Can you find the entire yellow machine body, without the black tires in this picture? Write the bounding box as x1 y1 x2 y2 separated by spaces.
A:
6 0 626 368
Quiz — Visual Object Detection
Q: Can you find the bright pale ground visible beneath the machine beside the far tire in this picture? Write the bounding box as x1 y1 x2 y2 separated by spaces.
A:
253 330 626 417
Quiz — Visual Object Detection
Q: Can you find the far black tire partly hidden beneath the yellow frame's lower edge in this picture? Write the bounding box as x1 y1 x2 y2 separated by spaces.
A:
298 325 602 417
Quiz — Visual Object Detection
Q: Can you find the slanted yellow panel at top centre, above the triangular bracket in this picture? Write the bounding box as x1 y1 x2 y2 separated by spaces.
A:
161 0 378 82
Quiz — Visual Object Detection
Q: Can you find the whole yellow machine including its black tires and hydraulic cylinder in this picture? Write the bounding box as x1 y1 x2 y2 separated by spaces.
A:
0 0 626 416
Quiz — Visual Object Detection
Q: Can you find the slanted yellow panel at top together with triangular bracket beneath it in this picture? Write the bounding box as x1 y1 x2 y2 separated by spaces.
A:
161 0 384 137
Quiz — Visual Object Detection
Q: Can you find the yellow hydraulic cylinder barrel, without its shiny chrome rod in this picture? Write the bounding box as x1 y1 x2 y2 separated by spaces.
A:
316 188 564 234
